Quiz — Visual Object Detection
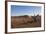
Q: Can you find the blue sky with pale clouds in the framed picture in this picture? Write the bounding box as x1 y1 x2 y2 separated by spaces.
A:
11 5 41 16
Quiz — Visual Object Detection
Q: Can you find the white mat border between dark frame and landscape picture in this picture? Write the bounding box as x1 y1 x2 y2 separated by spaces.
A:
7 2 44 32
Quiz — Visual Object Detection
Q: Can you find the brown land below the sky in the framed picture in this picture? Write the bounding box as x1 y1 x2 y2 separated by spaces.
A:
11 15 41 28
